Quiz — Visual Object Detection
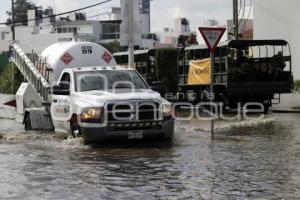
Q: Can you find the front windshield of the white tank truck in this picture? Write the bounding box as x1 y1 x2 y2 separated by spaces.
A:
75 70 148 92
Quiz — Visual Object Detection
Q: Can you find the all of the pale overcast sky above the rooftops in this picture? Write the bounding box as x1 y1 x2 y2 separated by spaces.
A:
0 0 239 29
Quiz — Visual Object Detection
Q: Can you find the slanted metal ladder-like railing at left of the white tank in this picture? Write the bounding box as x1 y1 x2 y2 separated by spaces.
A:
11 43 51 103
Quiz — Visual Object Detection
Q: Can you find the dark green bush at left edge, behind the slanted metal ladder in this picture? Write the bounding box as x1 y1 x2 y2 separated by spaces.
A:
0 64 24 94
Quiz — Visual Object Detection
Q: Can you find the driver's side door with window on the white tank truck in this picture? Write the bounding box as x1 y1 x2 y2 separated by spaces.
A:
51 72 72 133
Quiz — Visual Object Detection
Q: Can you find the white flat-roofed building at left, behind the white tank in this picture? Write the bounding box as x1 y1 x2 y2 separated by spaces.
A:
0 8 121 53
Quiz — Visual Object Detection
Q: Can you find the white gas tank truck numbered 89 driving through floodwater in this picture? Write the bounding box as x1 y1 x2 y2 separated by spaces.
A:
17 42 174 143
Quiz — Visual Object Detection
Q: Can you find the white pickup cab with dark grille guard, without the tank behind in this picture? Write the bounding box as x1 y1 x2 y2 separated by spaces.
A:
51 66 174 143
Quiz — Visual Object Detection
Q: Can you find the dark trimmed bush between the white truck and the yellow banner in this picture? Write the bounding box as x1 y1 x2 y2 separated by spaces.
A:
155 48 177 92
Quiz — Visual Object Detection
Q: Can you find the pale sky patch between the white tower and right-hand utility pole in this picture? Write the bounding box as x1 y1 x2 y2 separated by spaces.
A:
151 0 232 31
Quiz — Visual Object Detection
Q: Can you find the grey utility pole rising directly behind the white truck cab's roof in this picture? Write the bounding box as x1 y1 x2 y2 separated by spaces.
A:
127 0 134 68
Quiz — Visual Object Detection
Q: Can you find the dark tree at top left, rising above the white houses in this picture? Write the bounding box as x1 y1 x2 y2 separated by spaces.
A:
6 0 37 26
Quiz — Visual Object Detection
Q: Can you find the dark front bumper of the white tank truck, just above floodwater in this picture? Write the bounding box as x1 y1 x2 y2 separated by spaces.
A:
81 119 174 144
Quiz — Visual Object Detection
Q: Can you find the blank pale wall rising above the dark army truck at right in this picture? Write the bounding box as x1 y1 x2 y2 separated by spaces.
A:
254 0 300 79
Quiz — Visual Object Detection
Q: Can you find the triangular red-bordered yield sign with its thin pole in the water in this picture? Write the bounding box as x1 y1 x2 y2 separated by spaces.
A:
199 27 226 139
